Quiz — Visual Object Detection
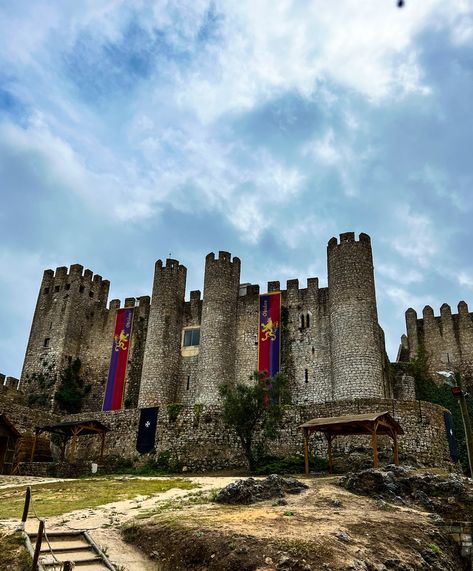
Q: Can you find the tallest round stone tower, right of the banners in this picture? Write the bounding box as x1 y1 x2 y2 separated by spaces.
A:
327 232 385 400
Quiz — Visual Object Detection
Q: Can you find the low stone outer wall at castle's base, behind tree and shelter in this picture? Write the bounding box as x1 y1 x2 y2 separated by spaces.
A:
68 399 450 471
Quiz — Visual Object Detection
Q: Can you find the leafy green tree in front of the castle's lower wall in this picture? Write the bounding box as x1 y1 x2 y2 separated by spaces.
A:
219 372 288 471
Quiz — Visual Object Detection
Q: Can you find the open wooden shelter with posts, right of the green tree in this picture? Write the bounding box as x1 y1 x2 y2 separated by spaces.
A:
300 411 404 474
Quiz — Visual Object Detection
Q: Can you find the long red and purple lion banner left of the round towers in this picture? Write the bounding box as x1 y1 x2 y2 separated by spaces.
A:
102 307 134 410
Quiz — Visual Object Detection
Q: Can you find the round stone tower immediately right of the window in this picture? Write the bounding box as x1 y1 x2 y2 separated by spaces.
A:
196 252 240 404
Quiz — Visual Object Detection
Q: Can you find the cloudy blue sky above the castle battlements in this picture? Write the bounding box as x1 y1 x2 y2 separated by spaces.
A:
0 0 473 375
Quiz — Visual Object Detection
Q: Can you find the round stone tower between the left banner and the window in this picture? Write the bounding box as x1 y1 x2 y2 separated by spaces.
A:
138 259 187 408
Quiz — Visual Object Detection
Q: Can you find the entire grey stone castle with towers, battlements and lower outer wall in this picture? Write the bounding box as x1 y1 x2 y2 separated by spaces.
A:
0 232 460 470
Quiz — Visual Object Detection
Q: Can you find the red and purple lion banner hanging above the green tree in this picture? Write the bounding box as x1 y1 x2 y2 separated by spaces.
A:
258 291 281 377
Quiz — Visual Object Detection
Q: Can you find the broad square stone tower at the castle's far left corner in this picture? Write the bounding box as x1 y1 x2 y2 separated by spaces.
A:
21 264 110 408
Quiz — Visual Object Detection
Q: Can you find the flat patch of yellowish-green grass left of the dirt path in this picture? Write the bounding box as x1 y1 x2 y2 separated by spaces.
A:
0 477 195 519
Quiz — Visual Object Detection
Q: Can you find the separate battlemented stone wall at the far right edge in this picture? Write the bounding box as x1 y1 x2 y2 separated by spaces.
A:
398 301 473 375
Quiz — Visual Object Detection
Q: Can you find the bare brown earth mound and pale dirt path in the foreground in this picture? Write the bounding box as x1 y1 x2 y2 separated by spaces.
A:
0 477 466 571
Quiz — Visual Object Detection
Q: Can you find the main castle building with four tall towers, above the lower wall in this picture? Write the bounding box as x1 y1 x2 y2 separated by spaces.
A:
21 232 394 411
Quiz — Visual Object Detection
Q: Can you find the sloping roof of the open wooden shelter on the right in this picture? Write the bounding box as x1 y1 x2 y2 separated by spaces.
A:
300 411 404 436
